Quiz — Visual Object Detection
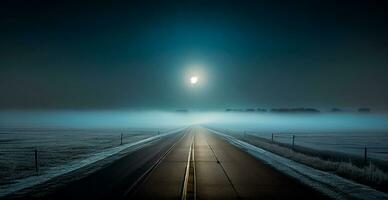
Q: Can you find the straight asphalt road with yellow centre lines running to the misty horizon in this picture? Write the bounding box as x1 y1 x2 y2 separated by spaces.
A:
6 127 327 200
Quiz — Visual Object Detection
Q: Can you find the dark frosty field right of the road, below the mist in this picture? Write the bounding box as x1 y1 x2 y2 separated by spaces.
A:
221 130 388 162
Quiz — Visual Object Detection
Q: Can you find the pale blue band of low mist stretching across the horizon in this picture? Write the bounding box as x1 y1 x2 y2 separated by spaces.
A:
0 111 388 132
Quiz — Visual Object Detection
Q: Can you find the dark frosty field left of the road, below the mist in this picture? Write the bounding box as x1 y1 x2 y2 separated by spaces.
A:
0 129 169 184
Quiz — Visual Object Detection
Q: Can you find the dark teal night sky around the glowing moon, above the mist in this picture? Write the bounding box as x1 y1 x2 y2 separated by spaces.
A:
0 0 388 109
